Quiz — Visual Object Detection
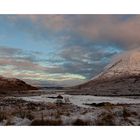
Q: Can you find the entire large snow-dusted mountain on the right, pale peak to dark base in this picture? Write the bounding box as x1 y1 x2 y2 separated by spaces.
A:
74 49 140 96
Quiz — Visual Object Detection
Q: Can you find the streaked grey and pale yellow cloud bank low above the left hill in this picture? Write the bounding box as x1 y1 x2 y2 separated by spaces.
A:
0 46 86 86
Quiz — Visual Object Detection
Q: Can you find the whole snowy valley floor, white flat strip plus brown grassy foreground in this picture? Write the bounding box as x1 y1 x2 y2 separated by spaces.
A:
0 94 140 126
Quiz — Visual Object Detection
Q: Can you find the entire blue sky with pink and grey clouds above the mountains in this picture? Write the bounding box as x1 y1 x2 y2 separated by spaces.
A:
0 14 140 86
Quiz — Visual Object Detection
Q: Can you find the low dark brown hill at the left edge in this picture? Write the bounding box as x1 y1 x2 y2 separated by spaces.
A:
0 76 37 91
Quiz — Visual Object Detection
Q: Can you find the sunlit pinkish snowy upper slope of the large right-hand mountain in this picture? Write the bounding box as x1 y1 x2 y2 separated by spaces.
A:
92 49 140 80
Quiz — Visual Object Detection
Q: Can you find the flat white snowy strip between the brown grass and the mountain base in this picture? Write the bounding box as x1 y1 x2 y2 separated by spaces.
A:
18 94 140 107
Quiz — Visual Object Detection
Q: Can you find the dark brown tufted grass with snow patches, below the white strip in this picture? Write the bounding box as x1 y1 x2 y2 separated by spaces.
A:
0 94 140 126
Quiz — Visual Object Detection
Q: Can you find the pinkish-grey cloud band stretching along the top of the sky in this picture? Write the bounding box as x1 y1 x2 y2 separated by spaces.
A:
8 14 140 49
